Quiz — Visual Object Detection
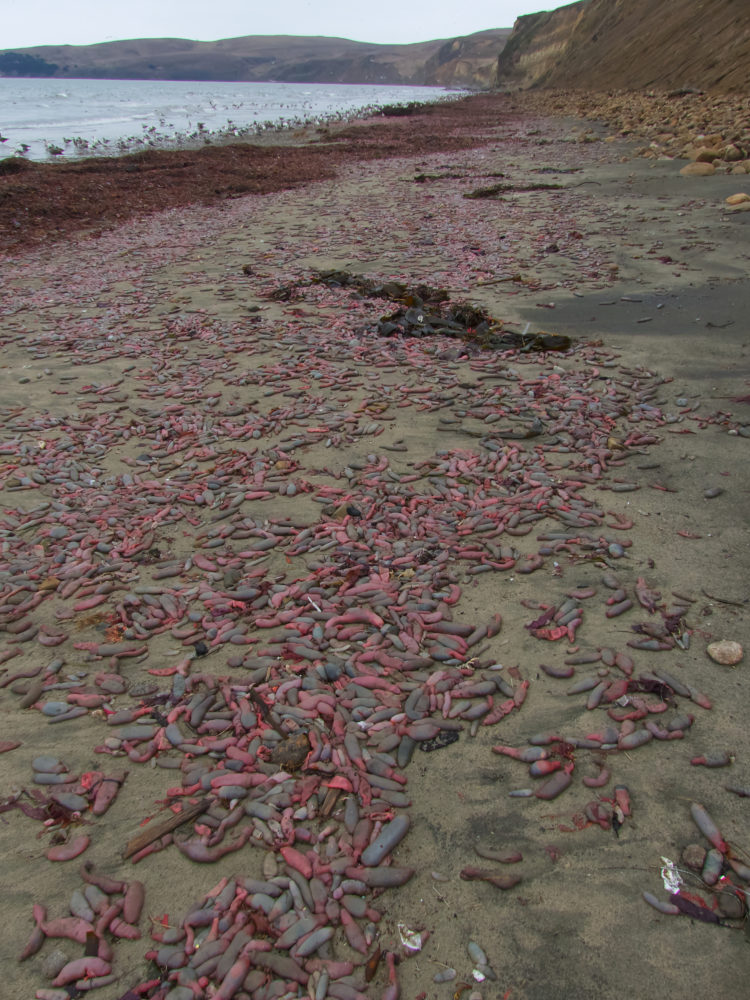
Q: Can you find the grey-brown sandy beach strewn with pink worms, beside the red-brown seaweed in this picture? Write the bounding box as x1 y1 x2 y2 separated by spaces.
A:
0 95 750 1000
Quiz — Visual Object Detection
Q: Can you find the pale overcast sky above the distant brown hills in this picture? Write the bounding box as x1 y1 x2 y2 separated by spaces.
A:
0 0 564 49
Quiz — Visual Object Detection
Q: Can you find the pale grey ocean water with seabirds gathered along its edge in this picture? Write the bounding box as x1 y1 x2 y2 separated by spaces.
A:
0 77 460 160
